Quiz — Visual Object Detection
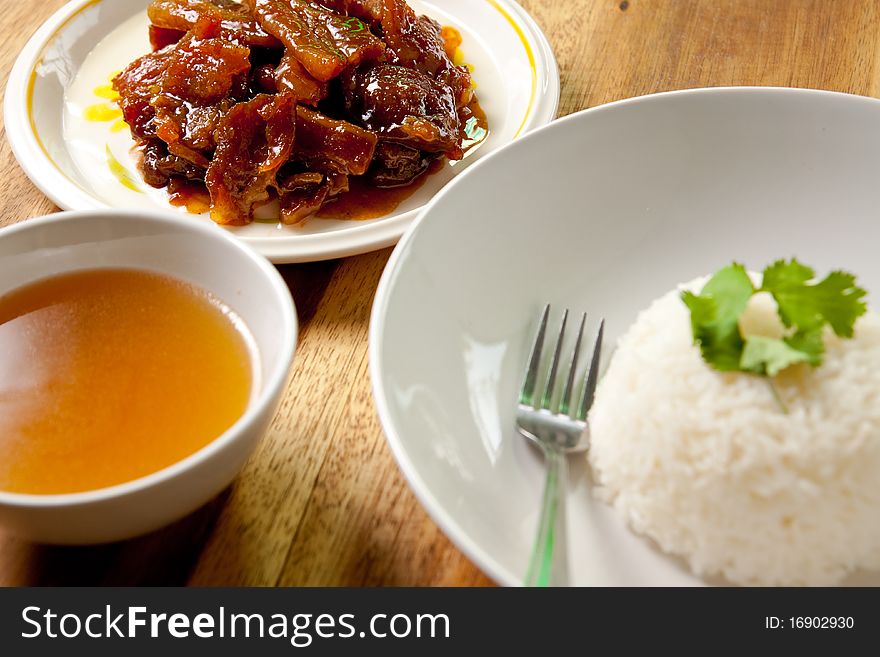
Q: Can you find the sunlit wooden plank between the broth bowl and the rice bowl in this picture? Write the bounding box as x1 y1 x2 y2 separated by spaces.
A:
192 252 387 586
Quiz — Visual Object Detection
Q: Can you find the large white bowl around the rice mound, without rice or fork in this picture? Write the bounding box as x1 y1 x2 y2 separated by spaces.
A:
370 88 880 586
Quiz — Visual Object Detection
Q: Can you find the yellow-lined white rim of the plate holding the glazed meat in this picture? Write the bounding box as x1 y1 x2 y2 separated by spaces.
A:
3 0 561 264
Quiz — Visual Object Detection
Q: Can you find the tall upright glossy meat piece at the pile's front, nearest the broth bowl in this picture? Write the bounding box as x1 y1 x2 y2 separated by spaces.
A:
205 94 297 225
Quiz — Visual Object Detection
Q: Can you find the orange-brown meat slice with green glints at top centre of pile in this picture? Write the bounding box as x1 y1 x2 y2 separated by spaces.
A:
249 0 385 82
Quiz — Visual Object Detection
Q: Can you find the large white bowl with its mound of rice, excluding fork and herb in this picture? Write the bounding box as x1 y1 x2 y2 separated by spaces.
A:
370 88 880 587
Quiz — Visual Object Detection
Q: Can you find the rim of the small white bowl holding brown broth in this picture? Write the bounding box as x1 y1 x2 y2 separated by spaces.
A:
0 209 299 508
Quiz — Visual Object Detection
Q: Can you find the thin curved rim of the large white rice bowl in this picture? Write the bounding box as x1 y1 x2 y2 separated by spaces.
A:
369 86 880 586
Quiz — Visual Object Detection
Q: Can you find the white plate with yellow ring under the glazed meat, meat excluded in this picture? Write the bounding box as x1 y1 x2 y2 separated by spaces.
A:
5 0 559 262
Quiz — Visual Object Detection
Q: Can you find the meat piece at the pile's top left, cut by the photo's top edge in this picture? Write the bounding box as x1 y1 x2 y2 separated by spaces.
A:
147 0 281 48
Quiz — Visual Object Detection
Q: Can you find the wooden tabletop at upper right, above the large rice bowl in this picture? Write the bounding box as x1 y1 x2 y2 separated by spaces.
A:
522 0 880 114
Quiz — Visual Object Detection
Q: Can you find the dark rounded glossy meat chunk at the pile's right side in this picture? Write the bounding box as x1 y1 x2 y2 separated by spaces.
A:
343 64 463 160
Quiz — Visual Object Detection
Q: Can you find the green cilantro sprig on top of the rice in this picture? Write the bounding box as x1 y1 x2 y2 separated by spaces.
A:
681 259 867 377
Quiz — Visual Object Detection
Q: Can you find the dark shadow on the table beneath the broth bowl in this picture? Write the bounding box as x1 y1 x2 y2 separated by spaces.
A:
10 488 231 586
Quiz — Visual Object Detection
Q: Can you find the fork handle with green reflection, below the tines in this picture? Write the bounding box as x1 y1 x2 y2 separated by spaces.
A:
524 449 568 586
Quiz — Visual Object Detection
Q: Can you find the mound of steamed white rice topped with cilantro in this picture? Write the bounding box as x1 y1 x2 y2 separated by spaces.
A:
589 281 880 585
